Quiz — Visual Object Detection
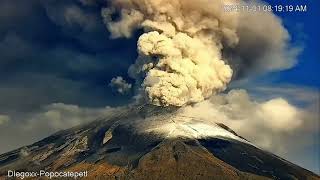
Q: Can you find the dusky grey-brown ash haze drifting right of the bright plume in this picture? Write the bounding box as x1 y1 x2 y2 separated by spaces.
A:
223 2 301 79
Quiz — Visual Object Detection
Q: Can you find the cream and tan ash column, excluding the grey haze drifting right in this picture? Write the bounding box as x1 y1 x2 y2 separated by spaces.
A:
102 1 238 106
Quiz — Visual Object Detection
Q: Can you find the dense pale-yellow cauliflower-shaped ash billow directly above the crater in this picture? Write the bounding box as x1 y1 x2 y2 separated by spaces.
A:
129 31 232 106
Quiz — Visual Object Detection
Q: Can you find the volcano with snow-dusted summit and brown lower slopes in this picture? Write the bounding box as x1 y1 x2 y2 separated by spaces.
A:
0 106 320 180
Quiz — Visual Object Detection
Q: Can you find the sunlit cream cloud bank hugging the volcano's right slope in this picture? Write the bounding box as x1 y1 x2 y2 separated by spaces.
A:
181 90 320 169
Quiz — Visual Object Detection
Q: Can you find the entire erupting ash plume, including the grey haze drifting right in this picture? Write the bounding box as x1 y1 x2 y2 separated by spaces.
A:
102 0 296 106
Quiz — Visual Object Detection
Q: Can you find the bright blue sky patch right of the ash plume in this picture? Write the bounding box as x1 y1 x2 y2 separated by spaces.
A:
260 0 320 88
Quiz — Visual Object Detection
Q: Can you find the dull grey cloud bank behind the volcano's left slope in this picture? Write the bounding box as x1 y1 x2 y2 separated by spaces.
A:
0 103 120 153
